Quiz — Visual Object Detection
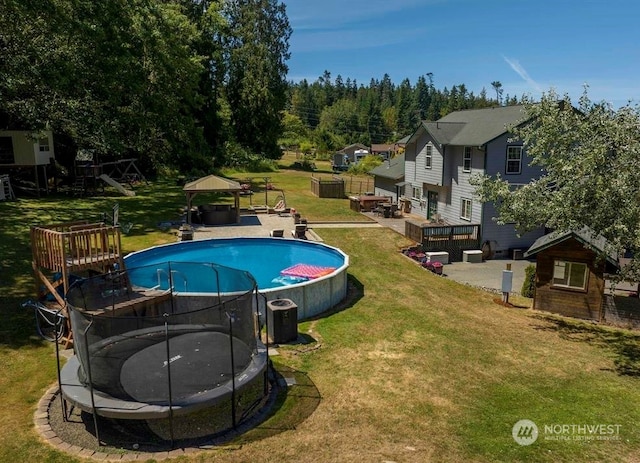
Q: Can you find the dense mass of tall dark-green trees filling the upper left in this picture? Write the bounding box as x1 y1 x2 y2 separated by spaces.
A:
0 0 290 174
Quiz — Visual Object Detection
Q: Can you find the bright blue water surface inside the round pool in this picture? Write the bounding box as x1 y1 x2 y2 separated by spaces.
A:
125 238 348 292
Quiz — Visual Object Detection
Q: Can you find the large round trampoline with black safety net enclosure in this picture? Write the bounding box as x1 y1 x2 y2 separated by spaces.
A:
60 264 268 440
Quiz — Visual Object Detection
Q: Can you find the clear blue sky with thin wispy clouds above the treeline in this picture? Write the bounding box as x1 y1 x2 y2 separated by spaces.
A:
283 0 640 107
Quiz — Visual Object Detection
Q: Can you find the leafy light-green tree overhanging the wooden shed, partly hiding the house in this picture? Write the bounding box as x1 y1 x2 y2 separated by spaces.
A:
476 89 640 281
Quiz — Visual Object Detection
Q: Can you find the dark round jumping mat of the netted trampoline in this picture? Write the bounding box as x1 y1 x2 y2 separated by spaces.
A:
120 331 251 403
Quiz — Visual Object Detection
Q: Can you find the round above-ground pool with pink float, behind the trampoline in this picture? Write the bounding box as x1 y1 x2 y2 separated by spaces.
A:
124 238 349 319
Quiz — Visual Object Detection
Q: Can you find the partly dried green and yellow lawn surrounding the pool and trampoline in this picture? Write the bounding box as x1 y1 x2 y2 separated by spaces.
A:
0 162 640 462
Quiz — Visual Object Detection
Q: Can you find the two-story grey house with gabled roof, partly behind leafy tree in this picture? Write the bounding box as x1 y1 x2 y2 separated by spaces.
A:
403 106 544 256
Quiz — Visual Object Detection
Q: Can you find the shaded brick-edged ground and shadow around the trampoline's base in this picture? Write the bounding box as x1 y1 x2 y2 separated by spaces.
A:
49 365 321 455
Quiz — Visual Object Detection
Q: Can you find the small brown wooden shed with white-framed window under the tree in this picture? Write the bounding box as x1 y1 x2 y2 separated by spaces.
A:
524 228 619 321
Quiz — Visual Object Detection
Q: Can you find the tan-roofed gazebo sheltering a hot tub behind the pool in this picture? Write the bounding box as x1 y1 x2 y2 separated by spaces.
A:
183 175 242 225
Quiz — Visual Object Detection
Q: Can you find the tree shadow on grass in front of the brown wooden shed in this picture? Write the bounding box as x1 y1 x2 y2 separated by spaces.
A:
534 314 640 378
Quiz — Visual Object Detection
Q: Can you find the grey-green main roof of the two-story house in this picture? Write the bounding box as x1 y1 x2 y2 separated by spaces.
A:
410 105 525 146
